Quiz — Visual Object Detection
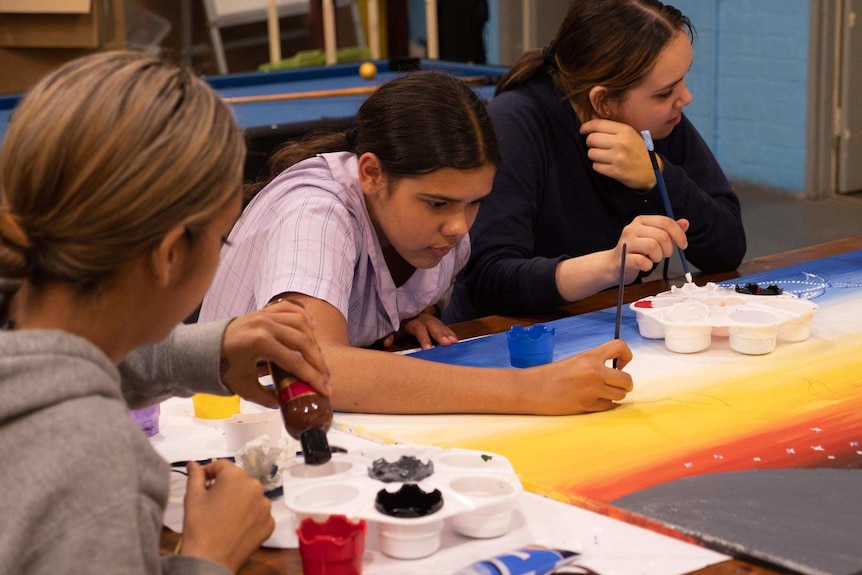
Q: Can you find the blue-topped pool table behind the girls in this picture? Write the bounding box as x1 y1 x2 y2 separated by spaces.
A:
0 59 507 179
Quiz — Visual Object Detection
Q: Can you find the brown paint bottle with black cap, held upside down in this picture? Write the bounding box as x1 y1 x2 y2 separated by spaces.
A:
269 362 332 465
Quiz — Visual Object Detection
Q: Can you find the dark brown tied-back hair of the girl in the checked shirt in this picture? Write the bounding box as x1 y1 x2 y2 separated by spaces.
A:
246 71 500 199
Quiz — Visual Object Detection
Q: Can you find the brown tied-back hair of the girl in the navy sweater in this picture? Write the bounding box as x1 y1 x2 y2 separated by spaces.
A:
497 0 695 110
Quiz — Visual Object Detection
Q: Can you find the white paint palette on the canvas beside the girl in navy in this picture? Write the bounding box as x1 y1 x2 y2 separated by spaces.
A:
629 282 819 355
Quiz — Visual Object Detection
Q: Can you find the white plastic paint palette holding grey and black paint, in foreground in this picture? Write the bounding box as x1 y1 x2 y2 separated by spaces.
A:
282 445 523 559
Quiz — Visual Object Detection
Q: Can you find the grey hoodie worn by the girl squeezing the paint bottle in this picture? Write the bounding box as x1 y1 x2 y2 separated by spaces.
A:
0 321 236 575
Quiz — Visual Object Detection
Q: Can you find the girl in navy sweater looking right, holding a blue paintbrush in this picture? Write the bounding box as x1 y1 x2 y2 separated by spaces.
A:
444 0 745 322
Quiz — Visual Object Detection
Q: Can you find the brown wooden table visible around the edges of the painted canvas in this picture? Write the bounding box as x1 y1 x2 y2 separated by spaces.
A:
161 236 862 575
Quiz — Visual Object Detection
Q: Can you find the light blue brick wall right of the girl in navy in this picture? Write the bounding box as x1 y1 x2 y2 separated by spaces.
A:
660 0 809 194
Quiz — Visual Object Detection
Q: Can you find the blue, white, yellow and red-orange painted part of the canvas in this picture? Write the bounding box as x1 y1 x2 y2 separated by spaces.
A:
336 251 862 572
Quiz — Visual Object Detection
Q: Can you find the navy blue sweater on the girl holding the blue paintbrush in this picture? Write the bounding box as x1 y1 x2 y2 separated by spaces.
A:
443 77 745 323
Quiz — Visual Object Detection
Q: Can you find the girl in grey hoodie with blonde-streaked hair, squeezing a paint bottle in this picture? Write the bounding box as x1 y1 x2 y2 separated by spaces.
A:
0 52 328 574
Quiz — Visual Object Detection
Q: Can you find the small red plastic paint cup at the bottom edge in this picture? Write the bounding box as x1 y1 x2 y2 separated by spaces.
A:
296 515 367 575
